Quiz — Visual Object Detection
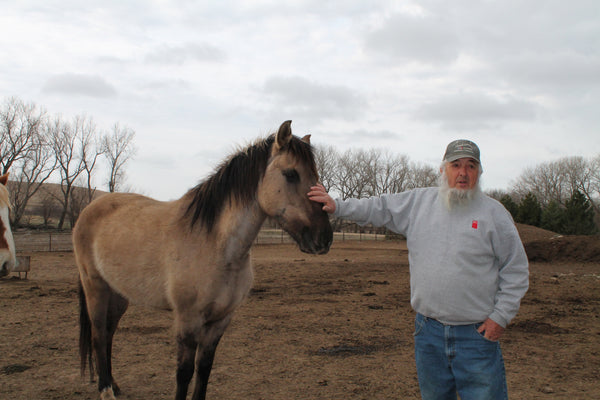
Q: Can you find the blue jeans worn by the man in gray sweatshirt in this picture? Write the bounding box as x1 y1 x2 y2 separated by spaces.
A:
415 314 508 400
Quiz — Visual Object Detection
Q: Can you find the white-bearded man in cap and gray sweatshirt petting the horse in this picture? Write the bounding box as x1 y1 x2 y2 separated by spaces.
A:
308 140 529 400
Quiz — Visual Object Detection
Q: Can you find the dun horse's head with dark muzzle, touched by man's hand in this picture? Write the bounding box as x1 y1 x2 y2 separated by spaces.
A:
257 121 333 254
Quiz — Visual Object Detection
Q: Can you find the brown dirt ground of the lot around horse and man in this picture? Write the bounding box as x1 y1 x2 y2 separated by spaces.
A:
0 226 600 400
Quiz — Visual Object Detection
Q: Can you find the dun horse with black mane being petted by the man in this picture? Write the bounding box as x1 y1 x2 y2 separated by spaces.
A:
73 121 333 400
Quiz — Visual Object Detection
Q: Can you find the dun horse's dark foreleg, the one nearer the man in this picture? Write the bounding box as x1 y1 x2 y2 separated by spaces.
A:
192 316 231 400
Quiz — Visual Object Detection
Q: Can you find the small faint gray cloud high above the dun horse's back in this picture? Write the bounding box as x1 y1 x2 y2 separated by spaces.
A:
145 43 227 65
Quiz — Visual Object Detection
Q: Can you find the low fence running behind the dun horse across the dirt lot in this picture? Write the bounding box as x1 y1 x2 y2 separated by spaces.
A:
13 229 386 253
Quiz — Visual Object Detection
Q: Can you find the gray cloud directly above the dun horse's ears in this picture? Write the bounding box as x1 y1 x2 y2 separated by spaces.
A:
263 76 367 120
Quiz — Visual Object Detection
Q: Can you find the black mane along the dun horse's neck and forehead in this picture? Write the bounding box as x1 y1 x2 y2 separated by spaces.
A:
185 134 317 232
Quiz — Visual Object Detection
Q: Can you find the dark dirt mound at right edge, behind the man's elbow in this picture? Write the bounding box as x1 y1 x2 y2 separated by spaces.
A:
517 224 600 262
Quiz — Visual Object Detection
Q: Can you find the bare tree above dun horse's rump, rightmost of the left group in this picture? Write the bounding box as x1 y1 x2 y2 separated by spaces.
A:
102 123 137 193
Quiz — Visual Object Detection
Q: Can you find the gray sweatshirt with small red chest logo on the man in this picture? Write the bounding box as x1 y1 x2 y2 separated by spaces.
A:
335 188 529 327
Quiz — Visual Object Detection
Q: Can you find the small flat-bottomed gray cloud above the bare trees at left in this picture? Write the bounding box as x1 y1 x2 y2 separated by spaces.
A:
42 74 117 97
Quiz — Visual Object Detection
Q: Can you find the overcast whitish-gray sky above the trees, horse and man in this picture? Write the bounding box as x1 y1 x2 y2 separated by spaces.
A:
0 0 600 200
